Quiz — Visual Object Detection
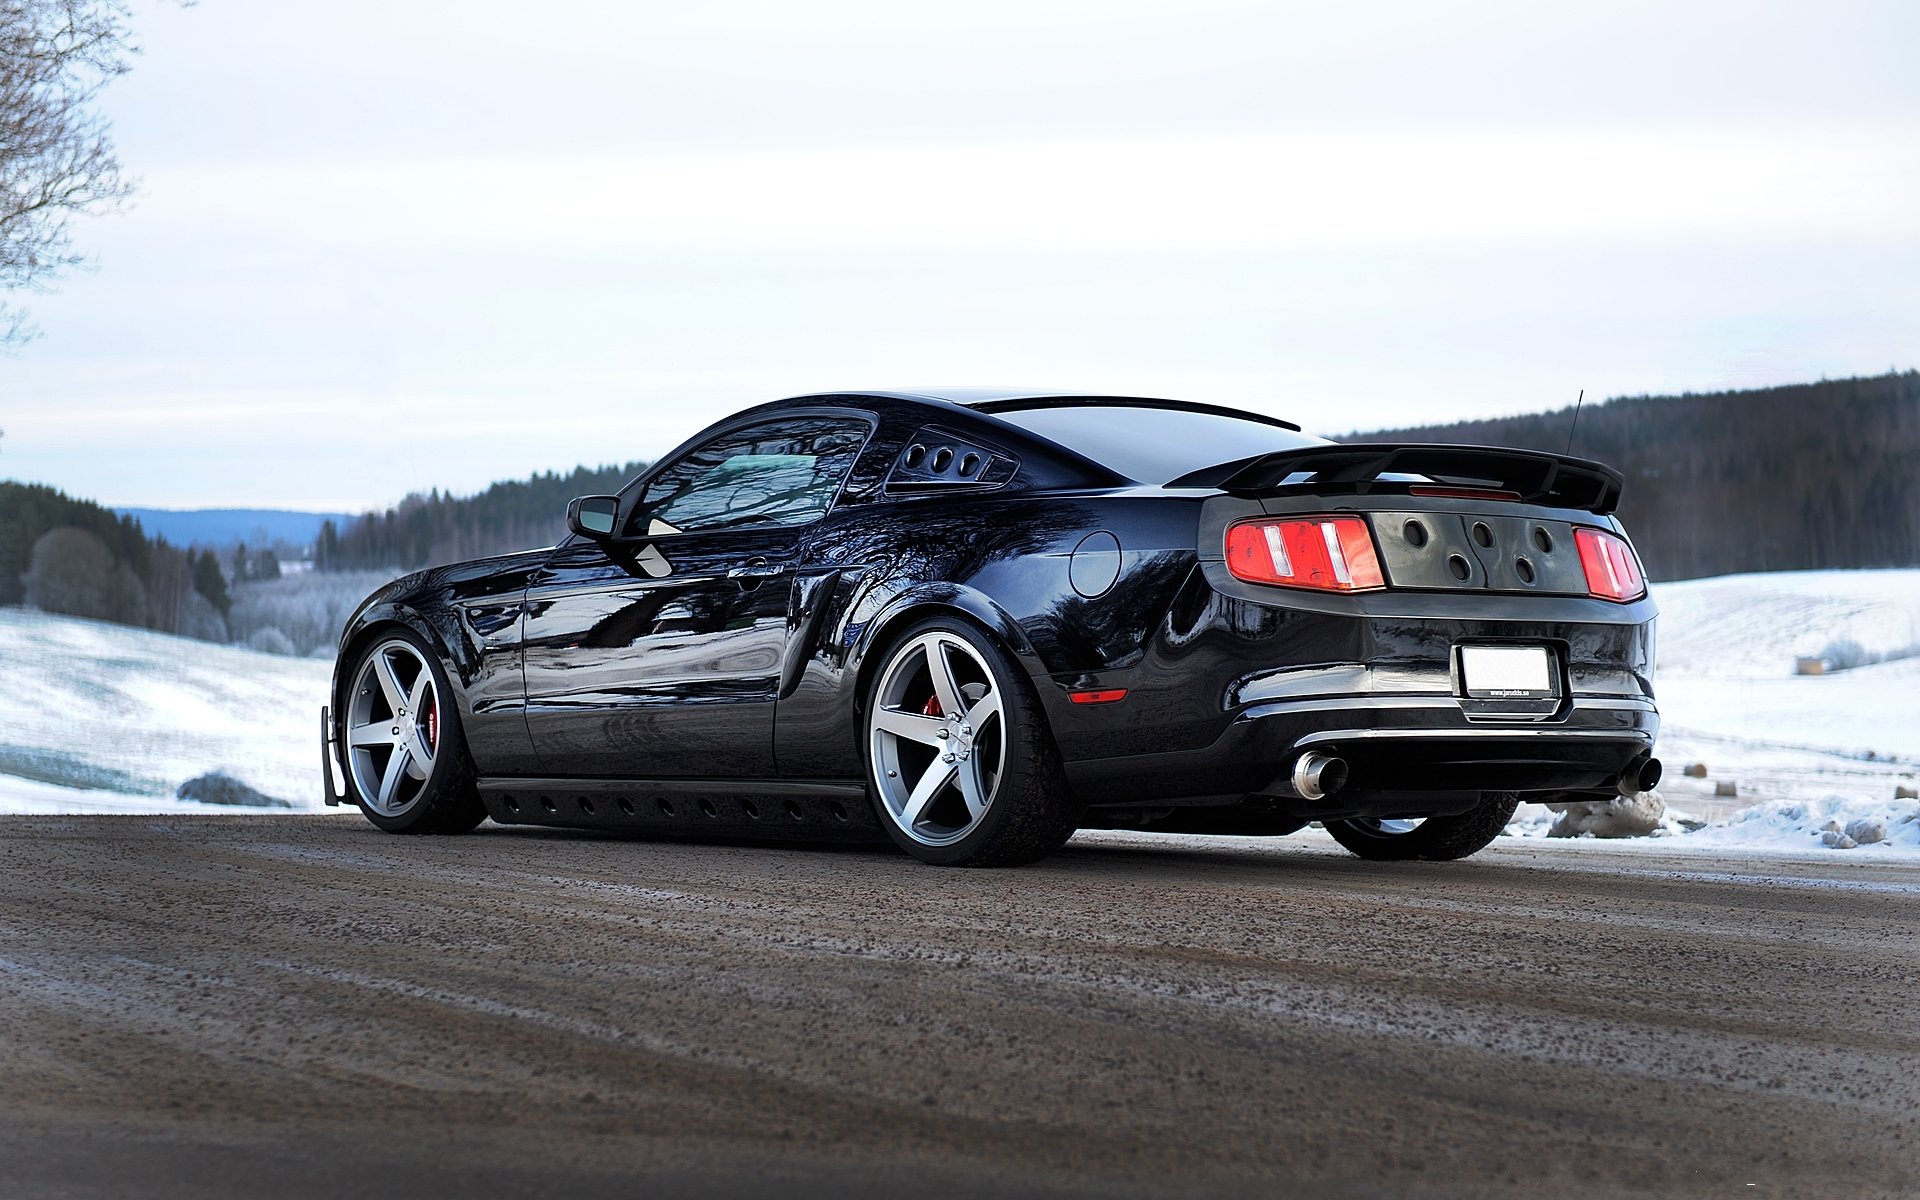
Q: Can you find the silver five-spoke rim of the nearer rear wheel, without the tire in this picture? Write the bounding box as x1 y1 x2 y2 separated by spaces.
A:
868 630 1008 847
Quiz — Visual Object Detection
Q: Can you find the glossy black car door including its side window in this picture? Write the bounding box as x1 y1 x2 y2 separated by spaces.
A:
524 415 872 780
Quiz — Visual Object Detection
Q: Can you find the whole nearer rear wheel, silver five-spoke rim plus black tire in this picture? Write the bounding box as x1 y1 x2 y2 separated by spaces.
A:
866 618 1077 866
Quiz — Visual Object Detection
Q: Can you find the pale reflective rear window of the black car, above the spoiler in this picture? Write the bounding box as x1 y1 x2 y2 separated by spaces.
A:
989 403 1327 484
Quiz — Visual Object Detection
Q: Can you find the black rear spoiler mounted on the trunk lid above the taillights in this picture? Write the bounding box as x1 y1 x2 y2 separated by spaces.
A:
1167 442 1624 515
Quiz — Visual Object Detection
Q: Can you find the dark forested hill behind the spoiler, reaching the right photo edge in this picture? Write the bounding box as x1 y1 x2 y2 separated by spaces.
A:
1352 371 1920 580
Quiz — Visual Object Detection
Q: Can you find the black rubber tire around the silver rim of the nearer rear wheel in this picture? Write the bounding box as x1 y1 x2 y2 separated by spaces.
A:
860 616 1081 866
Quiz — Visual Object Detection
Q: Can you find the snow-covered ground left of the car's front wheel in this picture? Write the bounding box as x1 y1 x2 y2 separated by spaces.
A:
0 609 332 812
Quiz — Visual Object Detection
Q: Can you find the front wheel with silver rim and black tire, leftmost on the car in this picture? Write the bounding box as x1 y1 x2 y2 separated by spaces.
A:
342 630 486 833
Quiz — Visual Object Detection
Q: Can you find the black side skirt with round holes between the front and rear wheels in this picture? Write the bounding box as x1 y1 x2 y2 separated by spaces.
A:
480 776 887 841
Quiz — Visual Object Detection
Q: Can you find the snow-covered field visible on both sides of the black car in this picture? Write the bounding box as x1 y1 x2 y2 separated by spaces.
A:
0 570 1920 860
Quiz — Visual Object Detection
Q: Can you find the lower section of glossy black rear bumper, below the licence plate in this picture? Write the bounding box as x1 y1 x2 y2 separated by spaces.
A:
1066 695 1659 816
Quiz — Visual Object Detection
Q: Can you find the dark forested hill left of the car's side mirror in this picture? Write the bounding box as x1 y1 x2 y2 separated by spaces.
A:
313 463 647 570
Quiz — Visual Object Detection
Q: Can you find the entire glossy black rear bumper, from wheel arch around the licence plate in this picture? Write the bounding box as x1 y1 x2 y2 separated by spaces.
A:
1041 545 1659 820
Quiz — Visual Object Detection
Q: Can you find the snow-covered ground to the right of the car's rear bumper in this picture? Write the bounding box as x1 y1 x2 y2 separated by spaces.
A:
1509 570 1920 858
